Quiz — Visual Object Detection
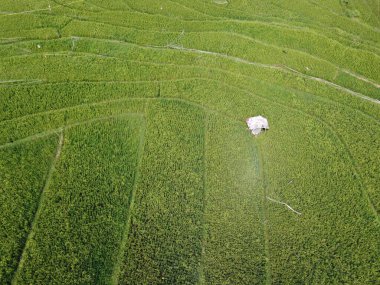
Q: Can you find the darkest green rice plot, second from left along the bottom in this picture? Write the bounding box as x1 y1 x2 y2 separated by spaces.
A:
15 117 144 284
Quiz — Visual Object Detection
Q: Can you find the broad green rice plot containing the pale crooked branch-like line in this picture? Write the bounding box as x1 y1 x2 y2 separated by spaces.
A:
260 110 380 284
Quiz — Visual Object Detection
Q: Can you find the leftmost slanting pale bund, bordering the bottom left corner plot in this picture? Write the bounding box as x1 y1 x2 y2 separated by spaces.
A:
11 128 64 285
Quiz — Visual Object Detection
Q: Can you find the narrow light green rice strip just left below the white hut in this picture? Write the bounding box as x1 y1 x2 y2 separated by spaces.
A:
201 113 268 284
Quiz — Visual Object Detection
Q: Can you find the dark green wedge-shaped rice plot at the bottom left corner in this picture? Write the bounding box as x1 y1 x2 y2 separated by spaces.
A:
0 136 58 284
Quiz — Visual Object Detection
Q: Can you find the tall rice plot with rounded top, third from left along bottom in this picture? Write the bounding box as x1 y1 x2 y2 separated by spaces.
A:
120 100 205 284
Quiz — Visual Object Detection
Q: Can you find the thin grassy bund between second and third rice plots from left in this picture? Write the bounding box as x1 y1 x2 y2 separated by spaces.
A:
111 114 147 285
